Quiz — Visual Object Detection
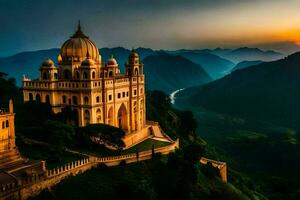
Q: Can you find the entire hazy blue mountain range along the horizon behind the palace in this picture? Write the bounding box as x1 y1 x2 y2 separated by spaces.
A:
0 47 281 93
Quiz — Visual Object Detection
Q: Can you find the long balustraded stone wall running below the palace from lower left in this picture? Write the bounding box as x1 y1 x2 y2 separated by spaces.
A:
0 139 179 199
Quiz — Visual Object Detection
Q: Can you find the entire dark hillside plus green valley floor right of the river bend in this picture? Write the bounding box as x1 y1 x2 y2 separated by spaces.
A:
176 52 300 199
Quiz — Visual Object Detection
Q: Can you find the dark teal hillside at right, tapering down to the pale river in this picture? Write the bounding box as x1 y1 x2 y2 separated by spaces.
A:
177 53 300 125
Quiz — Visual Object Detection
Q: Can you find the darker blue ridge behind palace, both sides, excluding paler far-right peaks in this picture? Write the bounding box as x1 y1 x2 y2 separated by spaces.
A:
0 47 212 93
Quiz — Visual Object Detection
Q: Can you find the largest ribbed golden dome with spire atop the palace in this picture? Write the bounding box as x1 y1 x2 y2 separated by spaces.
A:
60 23 100 61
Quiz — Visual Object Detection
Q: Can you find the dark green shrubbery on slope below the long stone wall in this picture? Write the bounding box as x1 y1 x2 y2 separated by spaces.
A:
31 151 248 200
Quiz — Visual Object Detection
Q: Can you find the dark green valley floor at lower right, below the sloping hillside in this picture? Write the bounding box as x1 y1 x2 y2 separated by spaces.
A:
176 103 300 200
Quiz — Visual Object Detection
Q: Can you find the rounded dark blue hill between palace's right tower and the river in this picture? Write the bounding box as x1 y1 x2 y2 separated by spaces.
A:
143 53 211 93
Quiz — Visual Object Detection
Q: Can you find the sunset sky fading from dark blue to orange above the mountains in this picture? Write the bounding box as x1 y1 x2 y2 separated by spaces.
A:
0 0 300 56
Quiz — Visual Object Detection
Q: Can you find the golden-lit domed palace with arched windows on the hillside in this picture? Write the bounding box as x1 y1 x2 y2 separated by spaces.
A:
23 24 150 147
